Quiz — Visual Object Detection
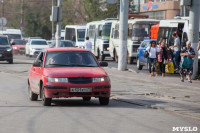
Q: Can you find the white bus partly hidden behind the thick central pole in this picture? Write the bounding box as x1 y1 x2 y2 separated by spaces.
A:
109 19 159 64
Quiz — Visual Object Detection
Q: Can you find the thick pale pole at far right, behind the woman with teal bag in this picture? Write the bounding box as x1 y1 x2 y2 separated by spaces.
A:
189 0 200 79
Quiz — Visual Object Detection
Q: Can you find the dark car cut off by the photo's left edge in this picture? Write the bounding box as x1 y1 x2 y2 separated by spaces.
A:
0 35 13 64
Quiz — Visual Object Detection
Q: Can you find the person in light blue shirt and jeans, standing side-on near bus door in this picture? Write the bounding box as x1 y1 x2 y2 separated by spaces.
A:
170 33 181 71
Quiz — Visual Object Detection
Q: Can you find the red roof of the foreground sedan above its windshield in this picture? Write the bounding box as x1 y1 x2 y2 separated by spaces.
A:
45 47 89 52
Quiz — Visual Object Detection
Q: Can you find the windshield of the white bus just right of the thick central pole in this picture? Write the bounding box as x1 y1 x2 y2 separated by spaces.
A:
132 23 150 41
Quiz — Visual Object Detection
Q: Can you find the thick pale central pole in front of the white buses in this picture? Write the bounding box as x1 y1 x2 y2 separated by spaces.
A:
118 0 129 71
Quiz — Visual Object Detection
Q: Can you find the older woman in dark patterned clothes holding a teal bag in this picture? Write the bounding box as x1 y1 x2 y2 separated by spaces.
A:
179 41 195 83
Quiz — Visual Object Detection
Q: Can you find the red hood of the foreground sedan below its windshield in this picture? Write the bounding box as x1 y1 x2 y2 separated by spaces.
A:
44 67 107 77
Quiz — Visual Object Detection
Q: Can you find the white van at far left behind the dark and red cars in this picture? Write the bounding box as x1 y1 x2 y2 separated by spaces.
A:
3 29 22 41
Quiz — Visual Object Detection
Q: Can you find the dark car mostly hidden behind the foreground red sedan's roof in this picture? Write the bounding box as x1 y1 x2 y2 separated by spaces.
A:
50 40 75 48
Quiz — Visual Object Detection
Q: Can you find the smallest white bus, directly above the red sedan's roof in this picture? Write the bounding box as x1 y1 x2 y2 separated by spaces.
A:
64 25 86 48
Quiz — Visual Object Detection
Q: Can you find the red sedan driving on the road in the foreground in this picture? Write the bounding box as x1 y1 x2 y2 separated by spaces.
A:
28 48 111 106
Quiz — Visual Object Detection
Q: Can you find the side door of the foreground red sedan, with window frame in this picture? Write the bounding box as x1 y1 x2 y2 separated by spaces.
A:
31 51 44 94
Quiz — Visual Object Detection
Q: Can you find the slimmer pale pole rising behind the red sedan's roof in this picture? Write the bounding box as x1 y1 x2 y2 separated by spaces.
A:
56 0 62 47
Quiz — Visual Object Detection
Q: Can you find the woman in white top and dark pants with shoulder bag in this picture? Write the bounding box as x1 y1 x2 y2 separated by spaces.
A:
146 41 160 77
